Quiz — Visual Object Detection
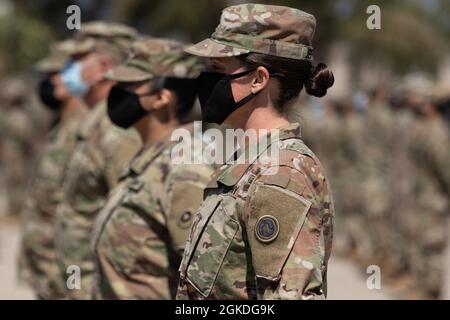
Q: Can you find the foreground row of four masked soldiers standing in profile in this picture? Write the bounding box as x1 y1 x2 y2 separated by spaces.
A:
8 4 334 299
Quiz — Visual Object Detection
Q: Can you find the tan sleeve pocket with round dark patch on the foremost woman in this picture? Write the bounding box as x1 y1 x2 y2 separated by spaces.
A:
246 184 311 280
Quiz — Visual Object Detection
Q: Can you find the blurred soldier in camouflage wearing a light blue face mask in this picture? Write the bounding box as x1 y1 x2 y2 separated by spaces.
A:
56 22 140 299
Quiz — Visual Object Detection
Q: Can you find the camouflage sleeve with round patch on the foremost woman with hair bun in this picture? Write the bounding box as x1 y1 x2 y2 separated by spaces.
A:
245 156 333 299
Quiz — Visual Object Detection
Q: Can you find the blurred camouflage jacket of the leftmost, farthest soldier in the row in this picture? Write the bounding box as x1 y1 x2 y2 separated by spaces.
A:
19 106 86 299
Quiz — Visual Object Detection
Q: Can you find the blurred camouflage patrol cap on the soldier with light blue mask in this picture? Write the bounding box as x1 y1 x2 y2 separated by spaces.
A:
67 21 138 55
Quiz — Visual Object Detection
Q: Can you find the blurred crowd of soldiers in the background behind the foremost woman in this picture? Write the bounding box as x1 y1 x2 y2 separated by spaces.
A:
303 84 450 299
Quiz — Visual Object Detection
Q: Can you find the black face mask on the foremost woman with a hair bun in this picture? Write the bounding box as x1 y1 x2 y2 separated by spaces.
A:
197 70 261 124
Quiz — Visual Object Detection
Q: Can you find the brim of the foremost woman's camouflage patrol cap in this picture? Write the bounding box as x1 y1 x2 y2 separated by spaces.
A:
184 39 250 58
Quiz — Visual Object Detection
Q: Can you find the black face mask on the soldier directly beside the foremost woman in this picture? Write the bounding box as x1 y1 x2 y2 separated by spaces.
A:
108 85 152 128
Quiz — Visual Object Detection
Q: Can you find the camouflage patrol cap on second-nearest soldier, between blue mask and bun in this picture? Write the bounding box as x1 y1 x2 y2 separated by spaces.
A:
104 38 204 82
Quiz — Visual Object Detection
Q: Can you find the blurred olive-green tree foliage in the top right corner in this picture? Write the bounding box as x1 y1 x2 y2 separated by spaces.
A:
338 0 449 73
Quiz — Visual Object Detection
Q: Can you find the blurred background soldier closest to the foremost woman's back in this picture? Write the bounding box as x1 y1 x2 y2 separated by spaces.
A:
302 106 373 256
